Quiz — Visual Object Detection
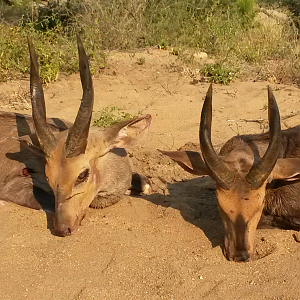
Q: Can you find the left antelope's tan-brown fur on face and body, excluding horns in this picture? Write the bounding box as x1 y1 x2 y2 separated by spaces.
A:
0 112 150 236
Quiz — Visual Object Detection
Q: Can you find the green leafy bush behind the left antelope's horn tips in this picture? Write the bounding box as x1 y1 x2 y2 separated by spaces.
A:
0 23 105 83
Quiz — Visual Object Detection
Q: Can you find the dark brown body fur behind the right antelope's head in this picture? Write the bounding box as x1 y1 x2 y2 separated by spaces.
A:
219 126 300 230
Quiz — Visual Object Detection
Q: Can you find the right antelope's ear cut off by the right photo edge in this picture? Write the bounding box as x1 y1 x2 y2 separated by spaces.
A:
268 158 300 182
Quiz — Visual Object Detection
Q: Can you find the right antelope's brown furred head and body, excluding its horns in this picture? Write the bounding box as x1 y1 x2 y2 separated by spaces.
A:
162 93 300 261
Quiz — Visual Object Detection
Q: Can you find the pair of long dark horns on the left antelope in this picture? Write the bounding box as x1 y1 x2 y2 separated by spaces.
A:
28 36 94 157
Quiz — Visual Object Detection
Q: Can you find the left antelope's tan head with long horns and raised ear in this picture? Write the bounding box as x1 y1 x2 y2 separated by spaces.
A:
28 37 151 236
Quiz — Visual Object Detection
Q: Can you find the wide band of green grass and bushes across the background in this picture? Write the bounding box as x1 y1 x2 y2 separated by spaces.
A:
0 0 300 83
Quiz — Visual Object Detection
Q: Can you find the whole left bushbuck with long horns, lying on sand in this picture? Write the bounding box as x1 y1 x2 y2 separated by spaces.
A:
0 37 151 236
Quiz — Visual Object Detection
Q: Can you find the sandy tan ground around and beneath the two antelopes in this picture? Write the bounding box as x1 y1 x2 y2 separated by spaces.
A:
0 49 300 300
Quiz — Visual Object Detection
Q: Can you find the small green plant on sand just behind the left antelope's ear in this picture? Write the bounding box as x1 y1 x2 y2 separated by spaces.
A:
93 106 137 128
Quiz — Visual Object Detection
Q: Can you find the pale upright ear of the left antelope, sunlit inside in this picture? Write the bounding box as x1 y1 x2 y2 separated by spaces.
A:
104 115 151 151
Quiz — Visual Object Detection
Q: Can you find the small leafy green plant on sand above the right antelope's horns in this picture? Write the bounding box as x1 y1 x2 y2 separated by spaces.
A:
202 62 236 84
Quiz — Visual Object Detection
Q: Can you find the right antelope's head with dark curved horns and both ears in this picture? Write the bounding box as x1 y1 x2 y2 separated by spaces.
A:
161 85 299 261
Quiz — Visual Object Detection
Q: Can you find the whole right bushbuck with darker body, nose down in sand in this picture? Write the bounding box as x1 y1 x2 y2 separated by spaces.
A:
161 85 300 261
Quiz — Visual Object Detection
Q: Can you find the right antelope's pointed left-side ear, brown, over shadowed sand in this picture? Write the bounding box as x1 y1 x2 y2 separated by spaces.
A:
158 150 209 175
